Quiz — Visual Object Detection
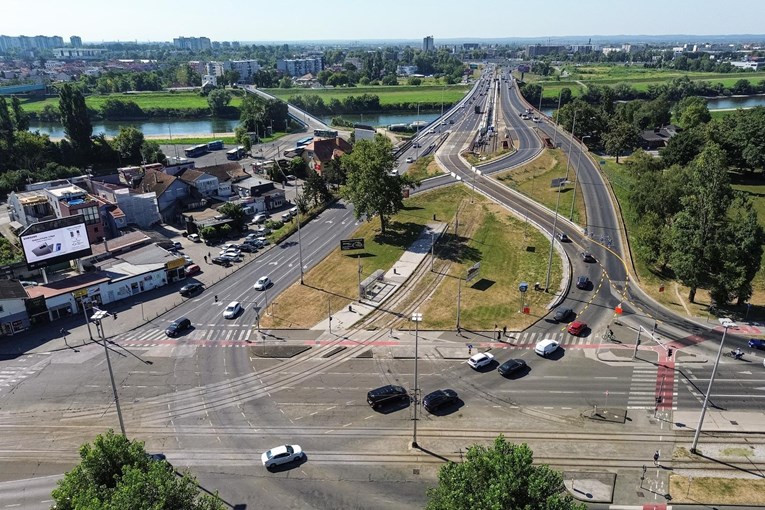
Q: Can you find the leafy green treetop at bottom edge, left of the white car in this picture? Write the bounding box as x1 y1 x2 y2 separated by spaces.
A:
52 430 224 510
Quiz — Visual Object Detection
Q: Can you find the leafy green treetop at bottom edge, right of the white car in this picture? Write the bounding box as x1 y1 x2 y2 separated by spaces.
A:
426 435 586 510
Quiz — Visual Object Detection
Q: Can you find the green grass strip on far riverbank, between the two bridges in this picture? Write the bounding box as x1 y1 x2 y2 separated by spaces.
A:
263 85 470 105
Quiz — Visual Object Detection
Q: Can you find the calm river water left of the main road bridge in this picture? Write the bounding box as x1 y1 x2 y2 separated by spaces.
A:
29 112 440 139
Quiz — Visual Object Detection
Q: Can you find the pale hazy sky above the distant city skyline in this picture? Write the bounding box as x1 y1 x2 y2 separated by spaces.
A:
0 0 765 44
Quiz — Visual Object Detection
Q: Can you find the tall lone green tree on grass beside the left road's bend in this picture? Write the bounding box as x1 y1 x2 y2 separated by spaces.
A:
340 134 412 234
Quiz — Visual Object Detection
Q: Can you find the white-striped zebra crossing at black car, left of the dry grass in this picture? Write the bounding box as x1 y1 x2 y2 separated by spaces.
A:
117 325 257 347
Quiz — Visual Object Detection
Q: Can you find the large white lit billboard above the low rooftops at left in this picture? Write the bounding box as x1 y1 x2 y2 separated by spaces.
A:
19 214 93 270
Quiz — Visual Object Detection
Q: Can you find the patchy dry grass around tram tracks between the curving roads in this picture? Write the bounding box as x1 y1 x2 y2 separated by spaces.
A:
261 186 561 330
